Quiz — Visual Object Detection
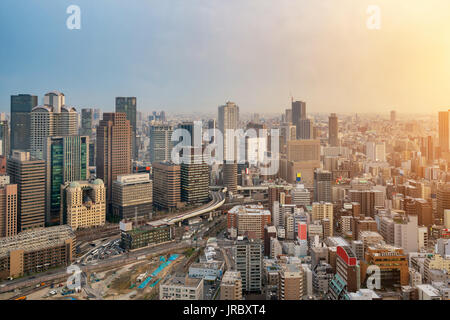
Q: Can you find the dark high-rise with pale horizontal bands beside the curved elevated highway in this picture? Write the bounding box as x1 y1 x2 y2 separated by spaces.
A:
180 147 209 203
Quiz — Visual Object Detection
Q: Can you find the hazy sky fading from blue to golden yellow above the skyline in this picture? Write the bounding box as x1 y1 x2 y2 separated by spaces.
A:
0 0 450 113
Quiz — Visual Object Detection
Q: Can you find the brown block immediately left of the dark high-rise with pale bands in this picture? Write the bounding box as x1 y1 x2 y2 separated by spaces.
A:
153 162 181 210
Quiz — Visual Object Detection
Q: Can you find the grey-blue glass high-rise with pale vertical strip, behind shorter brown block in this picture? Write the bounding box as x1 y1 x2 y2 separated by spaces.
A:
148 124 174 163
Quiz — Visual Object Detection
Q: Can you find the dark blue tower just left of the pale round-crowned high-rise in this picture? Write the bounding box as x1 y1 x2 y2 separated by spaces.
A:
10 94 38 153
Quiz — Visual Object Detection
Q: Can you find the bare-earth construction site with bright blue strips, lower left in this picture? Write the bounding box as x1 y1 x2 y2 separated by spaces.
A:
0 244 205 300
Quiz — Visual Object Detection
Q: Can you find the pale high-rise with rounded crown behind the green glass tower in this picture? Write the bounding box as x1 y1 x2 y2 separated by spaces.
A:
30 92 78 159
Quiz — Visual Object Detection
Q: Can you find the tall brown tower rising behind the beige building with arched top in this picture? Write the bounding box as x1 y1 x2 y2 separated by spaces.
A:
96 112 132 212
